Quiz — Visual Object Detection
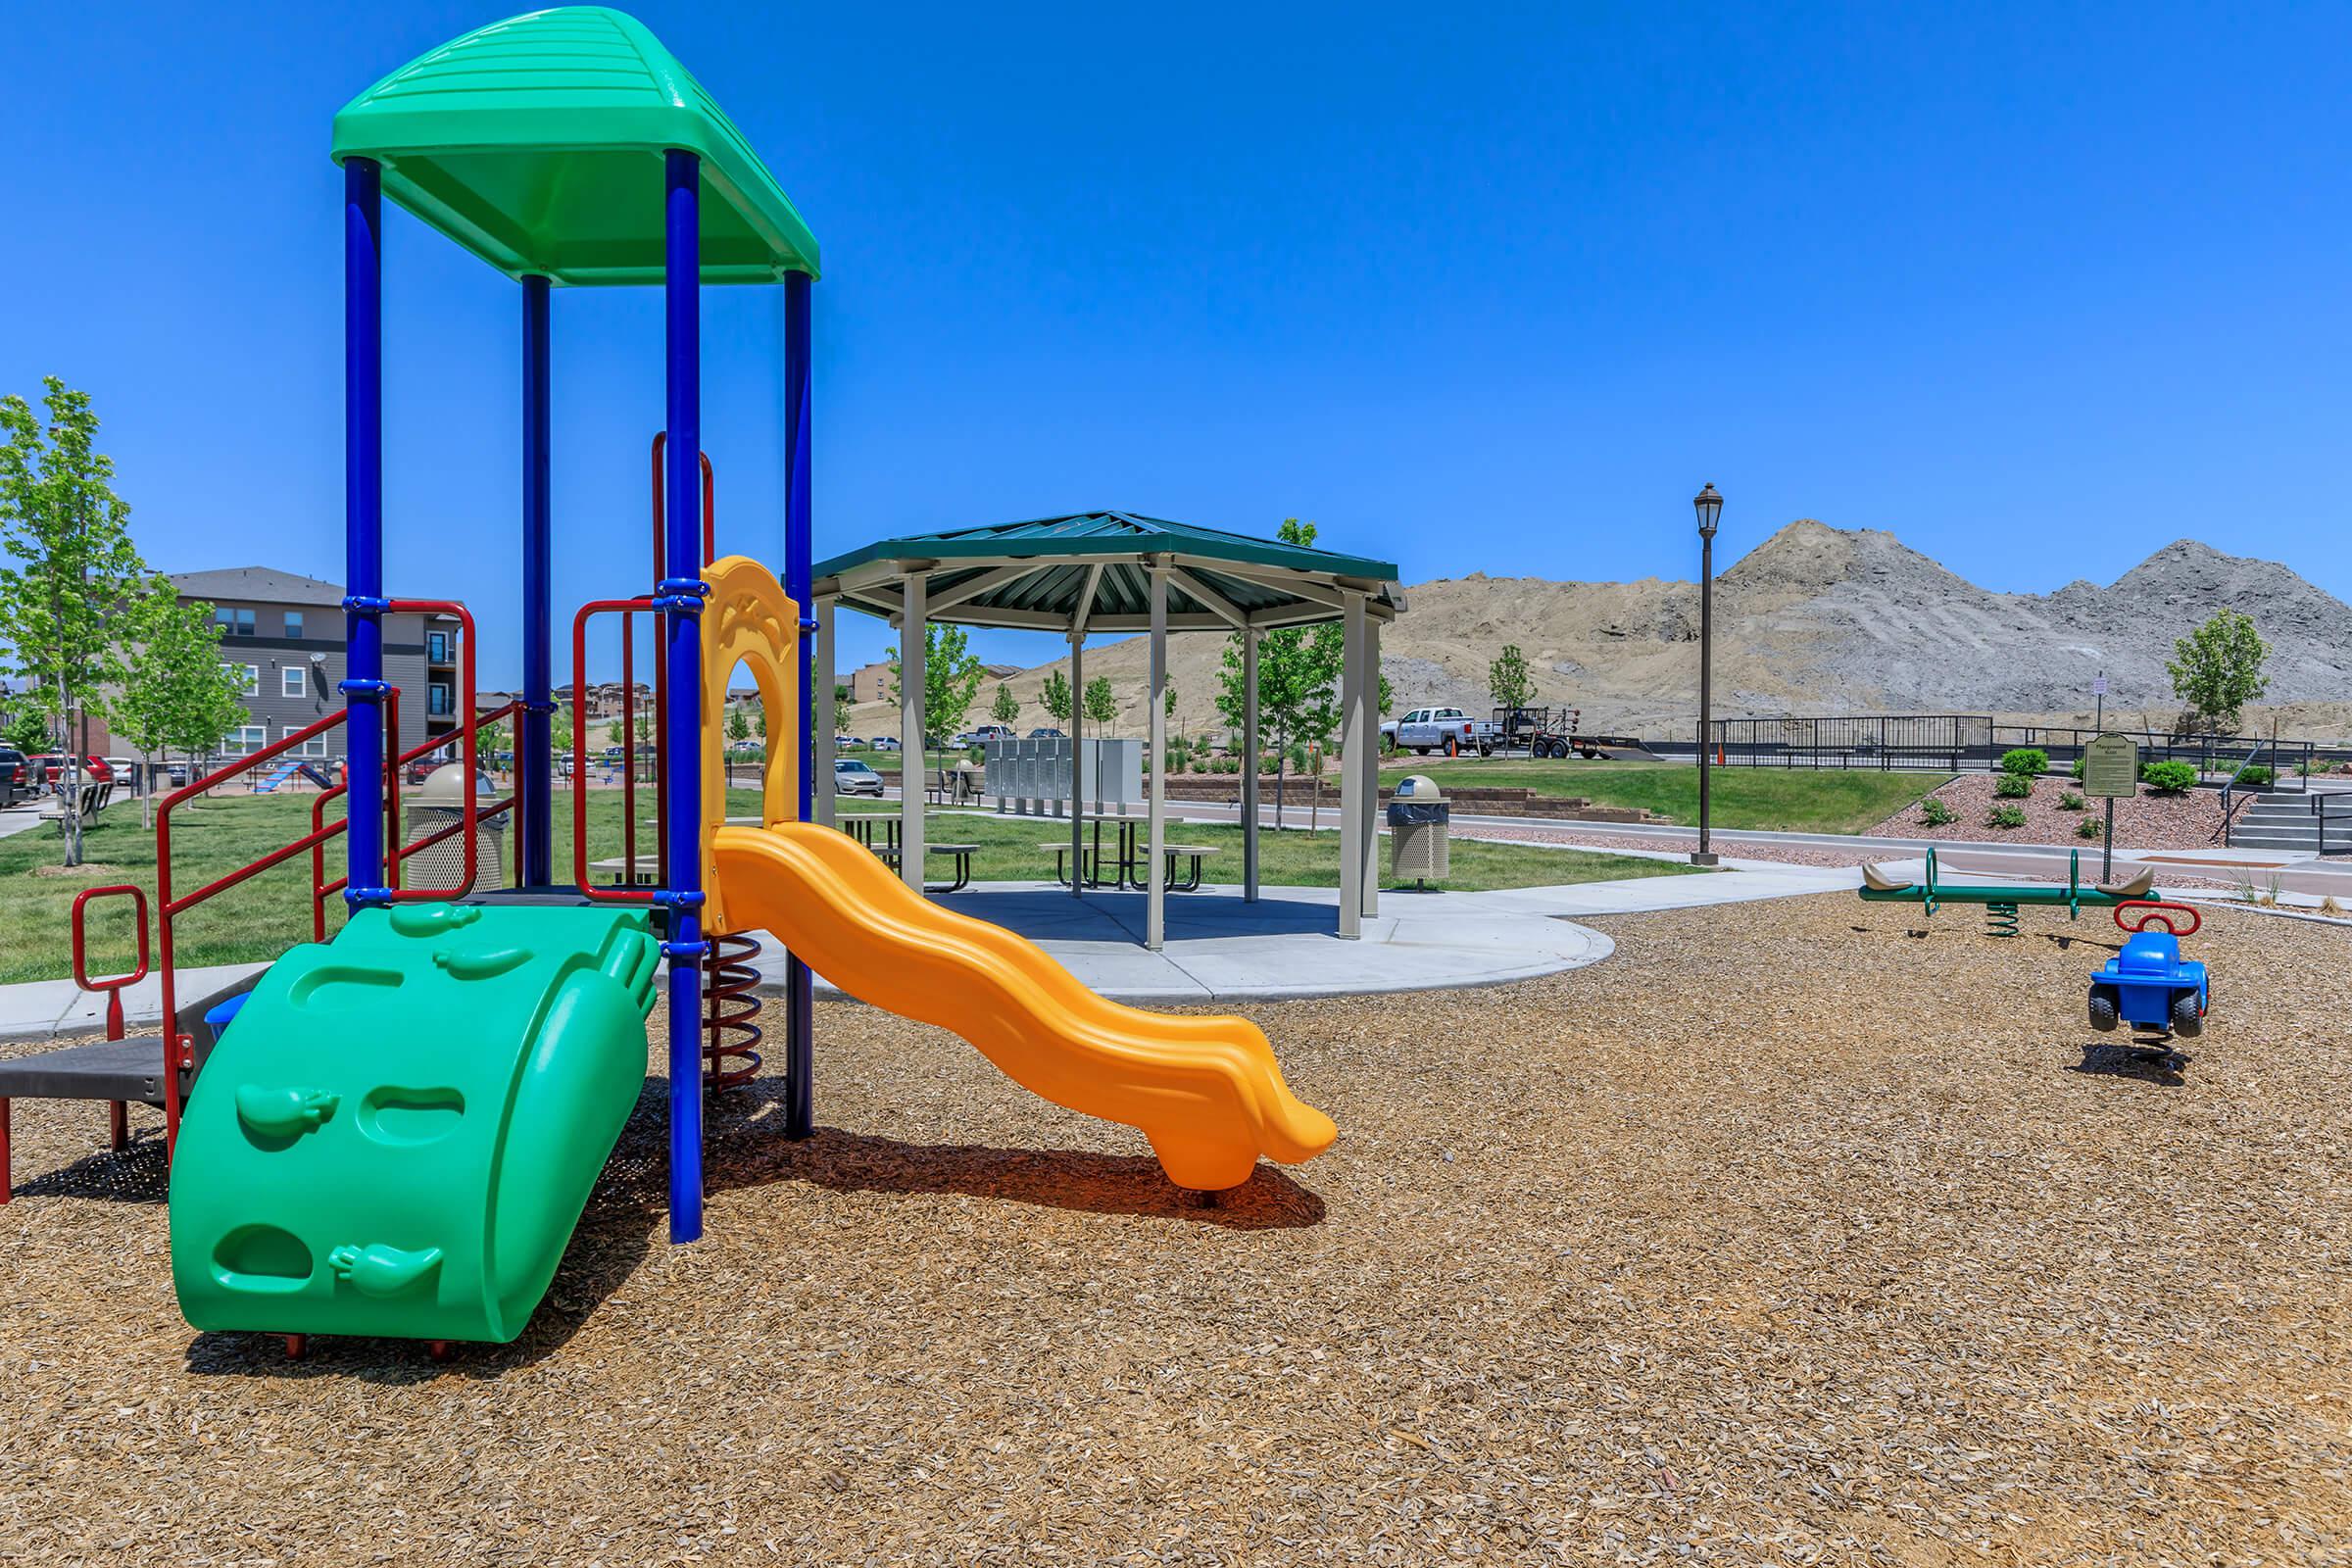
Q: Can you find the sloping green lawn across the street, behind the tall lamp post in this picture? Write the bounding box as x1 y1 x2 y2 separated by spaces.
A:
1383 757 1952 832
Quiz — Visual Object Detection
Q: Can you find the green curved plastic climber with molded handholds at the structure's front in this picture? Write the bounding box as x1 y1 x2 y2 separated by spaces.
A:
172 903 659 1343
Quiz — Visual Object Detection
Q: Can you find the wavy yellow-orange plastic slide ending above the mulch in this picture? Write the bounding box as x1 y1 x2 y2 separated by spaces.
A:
712 823 1339 1192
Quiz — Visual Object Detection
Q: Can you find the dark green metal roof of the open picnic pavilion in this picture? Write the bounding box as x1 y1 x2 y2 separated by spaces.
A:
813 513 1404 632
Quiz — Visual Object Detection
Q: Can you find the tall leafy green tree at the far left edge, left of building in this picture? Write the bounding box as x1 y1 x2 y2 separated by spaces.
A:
0 376 148 865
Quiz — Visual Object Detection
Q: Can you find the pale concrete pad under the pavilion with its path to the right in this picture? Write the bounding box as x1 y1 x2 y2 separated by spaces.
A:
758 867 1856 1004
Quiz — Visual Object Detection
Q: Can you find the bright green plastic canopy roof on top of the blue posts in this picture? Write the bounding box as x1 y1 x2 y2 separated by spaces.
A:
334 5 818 284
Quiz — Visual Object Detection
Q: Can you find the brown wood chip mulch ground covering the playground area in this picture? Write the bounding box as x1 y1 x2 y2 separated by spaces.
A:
0 896 2352 1566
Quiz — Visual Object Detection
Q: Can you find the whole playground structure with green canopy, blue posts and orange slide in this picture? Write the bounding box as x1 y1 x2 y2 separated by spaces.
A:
0 7 1334 1351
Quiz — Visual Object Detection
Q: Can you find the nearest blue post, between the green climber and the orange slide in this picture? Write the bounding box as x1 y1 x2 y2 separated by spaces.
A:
654 148 706 1244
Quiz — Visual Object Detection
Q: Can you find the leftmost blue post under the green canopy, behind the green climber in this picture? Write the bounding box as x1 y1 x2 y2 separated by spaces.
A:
343 158 388 907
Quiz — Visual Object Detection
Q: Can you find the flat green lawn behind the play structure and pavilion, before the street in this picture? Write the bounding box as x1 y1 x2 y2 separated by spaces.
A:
0 785 1689 983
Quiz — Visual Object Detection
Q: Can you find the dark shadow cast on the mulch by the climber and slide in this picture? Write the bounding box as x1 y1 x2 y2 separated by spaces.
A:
183 1077 1324 1385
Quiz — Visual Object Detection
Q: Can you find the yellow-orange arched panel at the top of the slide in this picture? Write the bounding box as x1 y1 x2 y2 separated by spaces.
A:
704 555 800 931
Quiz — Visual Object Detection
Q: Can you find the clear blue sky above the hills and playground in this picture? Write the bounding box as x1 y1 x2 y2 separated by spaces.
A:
0 0 2352 682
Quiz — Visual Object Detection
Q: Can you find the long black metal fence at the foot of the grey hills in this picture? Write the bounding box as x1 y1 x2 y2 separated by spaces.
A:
1710 712 2324 790
